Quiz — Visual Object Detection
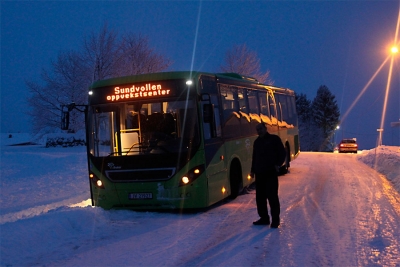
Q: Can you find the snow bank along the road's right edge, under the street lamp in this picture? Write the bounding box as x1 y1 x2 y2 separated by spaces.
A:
358 146 400 192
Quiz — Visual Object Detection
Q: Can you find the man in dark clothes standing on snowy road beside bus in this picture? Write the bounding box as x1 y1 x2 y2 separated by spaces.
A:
251 123 286 228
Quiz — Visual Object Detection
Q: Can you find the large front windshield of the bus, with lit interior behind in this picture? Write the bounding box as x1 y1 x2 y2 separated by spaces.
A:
88 99 200 157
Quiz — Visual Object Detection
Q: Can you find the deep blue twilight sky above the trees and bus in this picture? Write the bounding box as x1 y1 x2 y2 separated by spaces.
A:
0 0 400 149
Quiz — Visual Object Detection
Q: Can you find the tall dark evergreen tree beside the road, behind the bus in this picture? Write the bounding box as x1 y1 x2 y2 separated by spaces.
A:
311 85 340 151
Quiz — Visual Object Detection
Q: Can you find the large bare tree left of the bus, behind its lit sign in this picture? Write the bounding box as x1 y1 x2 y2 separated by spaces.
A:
26 24 171 133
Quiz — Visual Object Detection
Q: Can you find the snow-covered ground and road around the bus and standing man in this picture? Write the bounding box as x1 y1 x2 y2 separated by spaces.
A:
0 134 400 266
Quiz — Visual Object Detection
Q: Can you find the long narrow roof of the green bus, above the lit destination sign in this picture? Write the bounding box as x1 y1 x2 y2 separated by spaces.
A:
89 71 294 94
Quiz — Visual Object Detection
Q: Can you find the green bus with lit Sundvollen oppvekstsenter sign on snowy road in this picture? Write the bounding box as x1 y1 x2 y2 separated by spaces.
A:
65 71 299 210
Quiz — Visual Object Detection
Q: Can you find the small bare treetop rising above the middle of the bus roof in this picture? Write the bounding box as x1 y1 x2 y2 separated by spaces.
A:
220 44 273 84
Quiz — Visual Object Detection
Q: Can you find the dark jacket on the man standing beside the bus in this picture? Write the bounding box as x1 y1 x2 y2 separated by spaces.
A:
251 132 286 173
